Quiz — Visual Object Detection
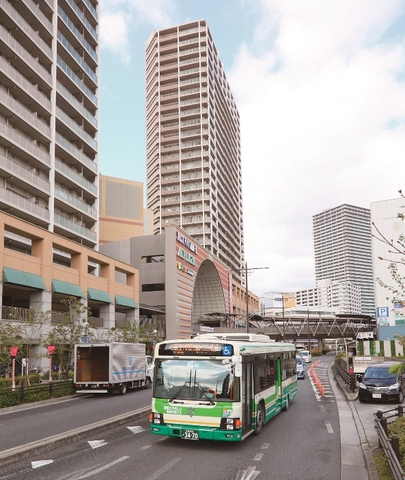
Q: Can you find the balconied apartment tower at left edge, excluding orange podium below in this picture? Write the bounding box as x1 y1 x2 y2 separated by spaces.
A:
0 0 98 248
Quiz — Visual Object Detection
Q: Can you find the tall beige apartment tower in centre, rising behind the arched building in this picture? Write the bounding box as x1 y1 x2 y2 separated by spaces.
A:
146 20 244 278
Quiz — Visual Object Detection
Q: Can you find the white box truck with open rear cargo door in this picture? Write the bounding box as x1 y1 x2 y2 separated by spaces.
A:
73 342 153 395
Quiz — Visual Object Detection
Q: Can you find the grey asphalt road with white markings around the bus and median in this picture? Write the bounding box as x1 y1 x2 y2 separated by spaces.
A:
0 357 341 480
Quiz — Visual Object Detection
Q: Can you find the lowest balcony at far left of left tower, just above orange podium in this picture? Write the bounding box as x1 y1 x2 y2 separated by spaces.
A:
0 187 50 228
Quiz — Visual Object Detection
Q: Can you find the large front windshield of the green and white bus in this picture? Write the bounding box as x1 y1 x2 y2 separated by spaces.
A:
153 358 239 403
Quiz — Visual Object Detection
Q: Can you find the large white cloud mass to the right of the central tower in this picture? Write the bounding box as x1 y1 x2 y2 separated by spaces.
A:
228 0 405 292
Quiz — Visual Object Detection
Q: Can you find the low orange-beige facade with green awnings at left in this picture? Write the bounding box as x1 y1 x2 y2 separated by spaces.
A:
0 212 139 331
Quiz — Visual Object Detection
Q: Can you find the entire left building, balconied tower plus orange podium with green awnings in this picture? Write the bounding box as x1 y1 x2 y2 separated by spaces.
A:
0 0 139 338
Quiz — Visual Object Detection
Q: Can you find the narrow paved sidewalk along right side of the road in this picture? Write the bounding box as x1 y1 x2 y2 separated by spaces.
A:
329 364 379 480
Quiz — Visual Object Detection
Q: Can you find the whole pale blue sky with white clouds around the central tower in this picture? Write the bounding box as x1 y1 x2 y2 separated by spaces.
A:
99 0 405 296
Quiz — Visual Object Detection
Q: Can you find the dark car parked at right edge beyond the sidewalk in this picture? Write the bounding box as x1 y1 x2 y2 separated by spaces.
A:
359 362 405 403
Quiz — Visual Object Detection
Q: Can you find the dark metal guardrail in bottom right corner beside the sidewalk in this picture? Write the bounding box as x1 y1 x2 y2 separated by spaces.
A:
374 405 405 480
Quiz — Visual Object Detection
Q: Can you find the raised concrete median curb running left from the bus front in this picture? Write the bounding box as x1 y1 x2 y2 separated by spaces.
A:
0 407 150 466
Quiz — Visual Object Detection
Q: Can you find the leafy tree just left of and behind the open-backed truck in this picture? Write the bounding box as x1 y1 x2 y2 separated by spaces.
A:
44 297 95 379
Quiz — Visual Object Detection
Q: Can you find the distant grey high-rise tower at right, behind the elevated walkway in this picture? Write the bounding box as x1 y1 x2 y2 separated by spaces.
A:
313 204 375 317
